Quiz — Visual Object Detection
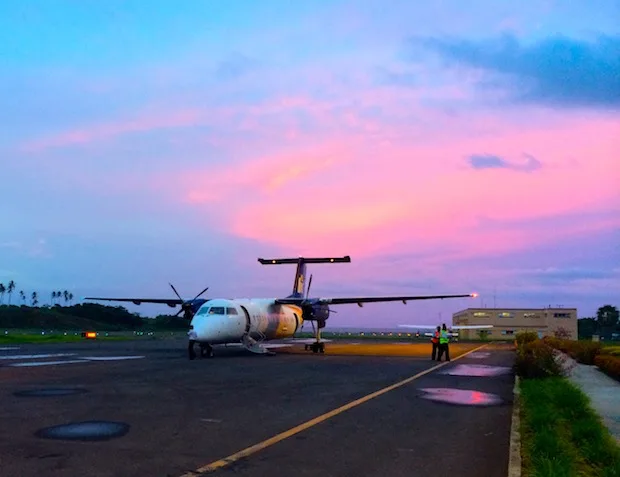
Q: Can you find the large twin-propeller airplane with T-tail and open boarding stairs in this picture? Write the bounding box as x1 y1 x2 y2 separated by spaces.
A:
84 255 478 359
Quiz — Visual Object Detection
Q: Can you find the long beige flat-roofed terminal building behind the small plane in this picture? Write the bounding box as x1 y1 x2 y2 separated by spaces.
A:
452 308 577 340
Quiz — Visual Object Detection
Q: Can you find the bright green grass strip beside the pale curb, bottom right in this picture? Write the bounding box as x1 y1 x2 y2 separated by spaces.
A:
520 377 620 477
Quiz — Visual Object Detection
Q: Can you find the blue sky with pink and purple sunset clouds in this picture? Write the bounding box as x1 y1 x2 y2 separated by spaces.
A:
0 0 620 327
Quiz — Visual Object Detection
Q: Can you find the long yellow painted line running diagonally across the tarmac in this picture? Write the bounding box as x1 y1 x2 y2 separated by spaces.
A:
181 343 488 477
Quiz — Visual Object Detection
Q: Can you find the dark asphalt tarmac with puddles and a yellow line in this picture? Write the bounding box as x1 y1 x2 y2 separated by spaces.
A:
0 340 514 477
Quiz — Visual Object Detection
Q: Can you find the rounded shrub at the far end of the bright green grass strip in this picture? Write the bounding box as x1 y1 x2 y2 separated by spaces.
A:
514 340 566 378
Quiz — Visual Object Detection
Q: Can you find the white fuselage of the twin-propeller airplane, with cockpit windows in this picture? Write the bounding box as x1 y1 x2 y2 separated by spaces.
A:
188 298 303 344
